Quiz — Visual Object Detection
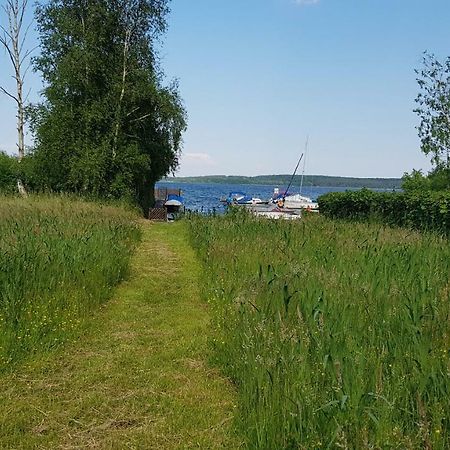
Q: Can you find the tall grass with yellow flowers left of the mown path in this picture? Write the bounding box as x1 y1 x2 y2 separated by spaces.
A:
0 197 139 370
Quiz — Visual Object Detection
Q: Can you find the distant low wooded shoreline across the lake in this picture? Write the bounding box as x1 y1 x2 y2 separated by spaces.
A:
161 174 402 189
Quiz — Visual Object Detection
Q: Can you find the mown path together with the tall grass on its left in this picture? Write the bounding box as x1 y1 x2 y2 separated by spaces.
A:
0 197 240 450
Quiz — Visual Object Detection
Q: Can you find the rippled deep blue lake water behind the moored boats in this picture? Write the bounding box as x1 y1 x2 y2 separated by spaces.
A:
156 182 364 212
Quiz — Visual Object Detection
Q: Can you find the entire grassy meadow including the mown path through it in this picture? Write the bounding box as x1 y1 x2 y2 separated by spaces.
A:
0 197 450 450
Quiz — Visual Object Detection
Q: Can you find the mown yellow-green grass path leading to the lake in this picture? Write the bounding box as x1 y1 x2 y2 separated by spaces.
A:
0 223 238 449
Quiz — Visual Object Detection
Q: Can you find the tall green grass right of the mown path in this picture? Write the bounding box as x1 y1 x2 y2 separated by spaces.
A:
190 213 450 449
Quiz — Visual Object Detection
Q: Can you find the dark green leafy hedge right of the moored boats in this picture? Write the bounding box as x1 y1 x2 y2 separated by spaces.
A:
318 189 450 235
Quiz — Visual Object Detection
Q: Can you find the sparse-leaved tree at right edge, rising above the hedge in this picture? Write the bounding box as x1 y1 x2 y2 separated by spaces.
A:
414 52 450 173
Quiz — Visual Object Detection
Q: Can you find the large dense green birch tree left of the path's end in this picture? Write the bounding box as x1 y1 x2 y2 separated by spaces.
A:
32 0 186 213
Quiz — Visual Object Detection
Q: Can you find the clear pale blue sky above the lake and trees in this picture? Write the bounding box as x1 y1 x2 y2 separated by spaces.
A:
0 0 450 177
